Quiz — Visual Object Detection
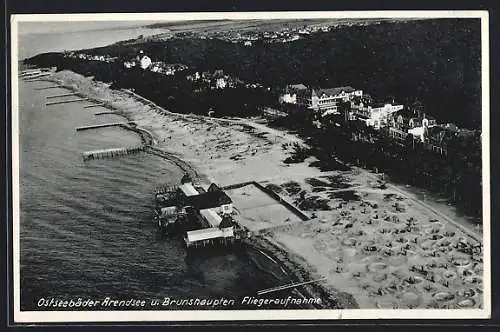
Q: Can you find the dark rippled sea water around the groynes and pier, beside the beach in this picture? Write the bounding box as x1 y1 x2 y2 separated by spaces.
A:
19 80 288 310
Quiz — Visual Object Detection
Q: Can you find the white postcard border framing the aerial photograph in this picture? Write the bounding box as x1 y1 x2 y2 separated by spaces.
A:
11 10 491 323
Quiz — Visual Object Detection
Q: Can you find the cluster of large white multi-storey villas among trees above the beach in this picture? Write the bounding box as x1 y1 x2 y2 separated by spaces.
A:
279 84 470 155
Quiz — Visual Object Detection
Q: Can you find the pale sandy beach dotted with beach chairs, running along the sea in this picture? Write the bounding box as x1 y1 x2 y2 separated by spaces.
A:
44 71 483 309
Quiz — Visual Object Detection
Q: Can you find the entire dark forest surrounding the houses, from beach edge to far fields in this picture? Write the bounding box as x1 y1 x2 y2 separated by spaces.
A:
27 19 482 220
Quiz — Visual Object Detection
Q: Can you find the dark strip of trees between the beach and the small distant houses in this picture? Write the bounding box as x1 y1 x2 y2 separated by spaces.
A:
26 53 278 116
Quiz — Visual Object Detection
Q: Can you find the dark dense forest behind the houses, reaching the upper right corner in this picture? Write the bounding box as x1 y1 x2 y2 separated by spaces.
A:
83 19 481 129
